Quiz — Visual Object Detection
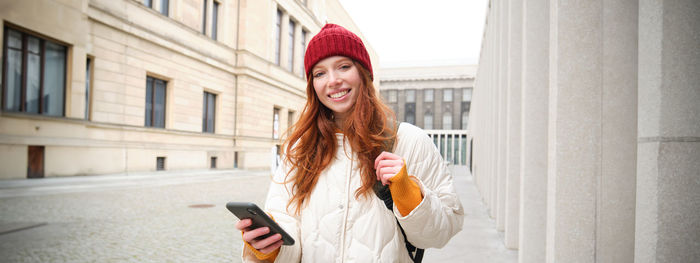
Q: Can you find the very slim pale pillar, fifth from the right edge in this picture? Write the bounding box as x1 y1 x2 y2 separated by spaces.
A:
496 1 510 231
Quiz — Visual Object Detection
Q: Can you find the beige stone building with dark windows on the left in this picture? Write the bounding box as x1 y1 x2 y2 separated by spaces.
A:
0 0 378 178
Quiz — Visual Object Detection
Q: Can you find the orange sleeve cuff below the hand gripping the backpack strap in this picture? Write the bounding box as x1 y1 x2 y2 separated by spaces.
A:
389 161 423 216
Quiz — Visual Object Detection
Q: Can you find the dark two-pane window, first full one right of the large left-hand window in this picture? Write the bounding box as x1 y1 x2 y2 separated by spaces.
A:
146 77 167 128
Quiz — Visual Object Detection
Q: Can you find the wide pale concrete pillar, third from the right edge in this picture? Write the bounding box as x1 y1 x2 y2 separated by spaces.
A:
546 0 603 263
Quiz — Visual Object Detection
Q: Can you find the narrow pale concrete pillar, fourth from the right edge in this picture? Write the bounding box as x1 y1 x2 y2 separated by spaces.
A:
518 0 549 263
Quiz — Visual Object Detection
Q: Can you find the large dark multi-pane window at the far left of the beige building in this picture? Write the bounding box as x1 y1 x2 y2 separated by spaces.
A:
3 27 66 116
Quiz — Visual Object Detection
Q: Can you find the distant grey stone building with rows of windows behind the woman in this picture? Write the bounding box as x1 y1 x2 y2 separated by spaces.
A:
379 66 476 130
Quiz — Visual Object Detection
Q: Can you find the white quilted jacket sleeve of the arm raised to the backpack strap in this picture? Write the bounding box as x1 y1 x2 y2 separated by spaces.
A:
394 123 464 248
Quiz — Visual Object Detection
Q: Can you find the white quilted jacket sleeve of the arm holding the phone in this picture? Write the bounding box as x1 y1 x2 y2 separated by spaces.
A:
241 164 301 262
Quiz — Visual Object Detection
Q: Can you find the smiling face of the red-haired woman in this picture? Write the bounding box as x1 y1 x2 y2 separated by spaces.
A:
311 56 363 123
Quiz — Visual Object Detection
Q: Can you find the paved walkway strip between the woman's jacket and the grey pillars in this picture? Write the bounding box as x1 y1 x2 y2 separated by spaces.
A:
423 166 518 263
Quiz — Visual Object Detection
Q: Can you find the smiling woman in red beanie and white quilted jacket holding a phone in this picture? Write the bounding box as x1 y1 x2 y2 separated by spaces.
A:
236 24 463 262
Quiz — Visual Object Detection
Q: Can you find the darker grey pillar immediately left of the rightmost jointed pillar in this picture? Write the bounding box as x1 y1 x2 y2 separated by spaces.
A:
596 0 639 262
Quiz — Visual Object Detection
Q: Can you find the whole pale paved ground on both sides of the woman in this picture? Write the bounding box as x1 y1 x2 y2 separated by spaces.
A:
0 167 517 263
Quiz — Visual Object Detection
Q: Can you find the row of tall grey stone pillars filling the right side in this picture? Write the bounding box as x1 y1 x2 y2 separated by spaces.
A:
468 0 700 263
